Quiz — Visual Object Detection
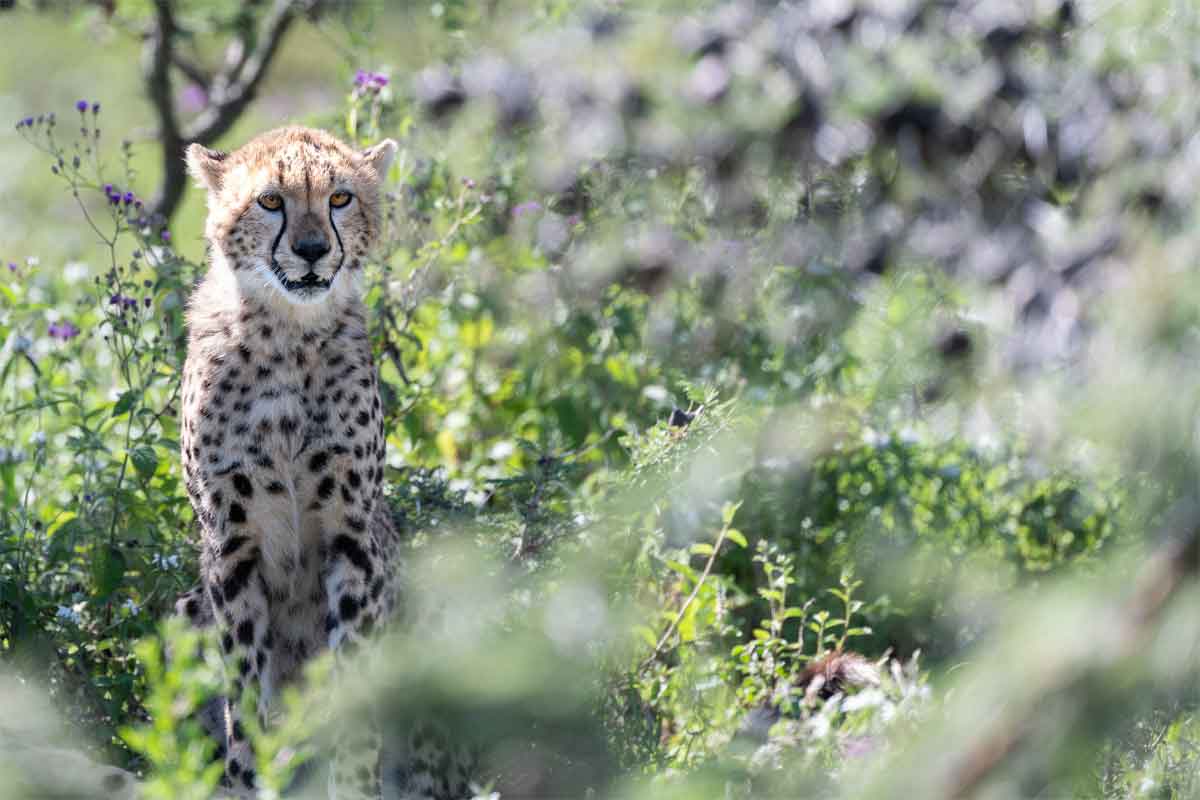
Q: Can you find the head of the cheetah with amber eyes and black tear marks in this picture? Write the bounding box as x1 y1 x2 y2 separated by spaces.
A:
187 127 396 306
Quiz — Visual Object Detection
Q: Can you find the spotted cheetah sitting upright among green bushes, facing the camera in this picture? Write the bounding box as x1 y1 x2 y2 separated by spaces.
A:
181 127 400 800
